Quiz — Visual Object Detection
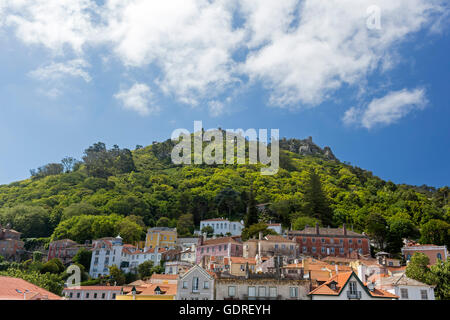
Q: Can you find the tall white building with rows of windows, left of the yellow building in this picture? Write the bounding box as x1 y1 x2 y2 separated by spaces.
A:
89 236 123 278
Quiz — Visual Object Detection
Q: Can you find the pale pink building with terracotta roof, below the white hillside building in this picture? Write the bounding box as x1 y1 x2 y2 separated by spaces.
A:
195 235 243 264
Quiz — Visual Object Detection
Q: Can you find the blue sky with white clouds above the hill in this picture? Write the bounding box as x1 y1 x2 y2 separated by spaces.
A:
0 0 450 186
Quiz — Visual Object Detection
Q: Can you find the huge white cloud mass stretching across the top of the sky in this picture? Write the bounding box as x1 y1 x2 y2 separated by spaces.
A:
0 0 448 108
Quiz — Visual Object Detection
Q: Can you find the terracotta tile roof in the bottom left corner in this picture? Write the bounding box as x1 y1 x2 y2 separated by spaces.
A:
0 276 62 300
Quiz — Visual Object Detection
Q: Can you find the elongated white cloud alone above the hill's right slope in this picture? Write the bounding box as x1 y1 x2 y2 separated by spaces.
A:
342 89 428 129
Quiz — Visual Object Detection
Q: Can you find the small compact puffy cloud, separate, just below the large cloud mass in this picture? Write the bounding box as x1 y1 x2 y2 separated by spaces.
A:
114 83 159 116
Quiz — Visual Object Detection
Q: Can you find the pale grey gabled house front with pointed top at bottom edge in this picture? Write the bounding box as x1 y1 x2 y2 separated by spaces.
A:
176 265 214 300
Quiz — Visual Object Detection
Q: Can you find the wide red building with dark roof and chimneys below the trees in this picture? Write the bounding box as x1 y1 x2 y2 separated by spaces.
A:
288 224 370 258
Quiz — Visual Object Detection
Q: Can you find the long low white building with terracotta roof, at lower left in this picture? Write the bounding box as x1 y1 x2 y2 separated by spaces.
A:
63 285 122 301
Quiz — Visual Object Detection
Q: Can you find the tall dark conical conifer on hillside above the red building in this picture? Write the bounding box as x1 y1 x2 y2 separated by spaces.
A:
305 171 333 225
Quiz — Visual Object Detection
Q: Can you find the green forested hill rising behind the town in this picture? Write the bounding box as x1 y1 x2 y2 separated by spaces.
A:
0 138 450 252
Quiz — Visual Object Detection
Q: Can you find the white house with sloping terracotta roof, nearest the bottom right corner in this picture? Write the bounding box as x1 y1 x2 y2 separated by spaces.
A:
375 273 435 300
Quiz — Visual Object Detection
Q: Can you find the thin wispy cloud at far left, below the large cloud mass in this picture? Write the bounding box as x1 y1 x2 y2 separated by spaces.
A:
29 59 91 82
